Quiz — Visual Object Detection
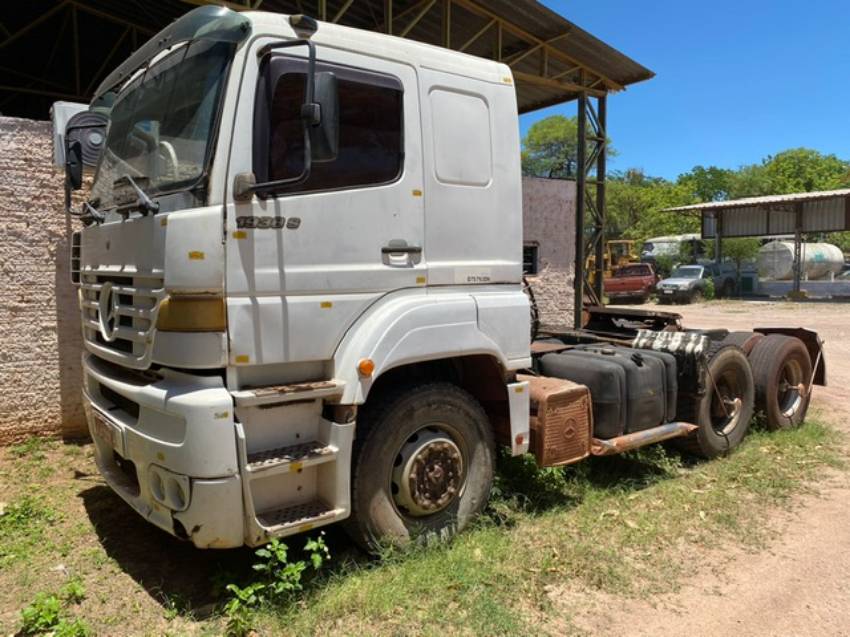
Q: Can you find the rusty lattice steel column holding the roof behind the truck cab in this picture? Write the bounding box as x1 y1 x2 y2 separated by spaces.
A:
574 93 608 328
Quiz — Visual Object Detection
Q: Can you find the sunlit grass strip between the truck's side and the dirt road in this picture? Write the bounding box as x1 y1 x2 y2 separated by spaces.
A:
247 422 841 635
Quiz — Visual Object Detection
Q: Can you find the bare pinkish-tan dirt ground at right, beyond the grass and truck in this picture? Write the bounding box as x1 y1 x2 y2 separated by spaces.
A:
576 301 850 637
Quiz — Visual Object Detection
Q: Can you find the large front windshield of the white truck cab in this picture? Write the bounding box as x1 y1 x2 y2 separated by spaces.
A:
92 40 233 208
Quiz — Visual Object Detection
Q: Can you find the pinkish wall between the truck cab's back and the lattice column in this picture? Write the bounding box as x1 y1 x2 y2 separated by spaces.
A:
522 177 576 326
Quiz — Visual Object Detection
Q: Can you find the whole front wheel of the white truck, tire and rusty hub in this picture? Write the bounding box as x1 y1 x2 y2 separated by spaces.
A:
346 383 496 553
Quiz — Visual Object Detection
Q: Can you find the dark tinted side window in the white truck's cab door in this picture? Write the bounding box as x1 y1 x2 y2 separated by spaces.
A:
254 60 404 194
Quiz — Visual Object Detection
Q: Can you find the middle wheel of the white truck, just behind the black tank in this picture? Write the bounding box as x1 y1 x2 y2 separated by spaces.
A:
678 342 755 458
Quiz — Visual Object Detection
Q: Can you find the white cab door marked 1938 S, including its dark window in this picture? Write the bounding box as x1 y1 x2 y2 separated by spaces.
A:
226 41 427 365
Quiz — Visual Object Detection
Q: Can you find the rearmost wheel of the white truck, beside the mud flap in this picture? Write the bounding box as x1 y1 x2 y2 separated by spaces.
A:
750 334 812 431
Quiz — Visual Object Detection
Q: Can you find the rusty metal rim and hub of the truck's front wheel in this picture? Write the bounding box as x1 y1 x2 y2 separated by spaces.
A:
390 425 466 517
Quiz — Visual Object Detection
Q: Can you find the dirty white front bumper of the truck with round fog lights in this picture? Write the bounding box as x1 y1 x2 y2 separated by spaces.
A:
83 354 245 548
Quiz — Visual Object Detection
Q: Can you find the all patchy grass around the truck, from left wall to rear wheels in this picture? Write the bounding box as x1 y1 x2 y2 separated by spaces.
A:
0 420 842 635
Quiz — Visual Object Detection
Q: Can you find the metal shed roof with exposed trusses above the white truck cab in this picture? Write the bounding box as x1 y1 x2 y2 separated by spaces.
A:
0 0 654 118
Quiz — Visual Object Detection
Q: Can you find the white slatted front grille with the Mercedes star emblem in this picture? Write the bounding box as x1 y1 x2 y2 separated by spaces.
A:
80 271 165 369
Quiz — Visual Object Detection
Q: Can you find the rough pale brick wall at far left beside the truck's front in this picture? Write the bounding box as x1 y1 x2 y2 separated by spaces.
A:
0 117 85 443
